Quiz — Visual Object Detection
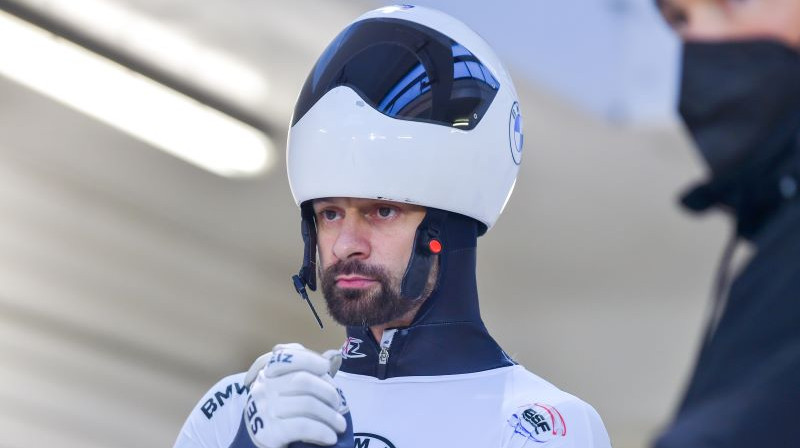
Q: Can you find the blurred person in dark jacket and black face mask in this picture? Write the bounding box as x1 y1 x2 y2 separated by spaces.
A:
655 0 800 448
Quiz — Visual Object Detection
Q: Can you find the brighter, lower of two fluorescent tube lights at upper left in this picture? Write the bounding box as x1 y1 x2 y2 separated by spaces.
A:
0 13 276 176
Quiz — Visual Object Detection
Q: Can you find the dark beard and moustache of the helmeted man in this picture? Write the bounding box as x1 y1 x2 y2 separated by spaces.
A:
320 259 438 327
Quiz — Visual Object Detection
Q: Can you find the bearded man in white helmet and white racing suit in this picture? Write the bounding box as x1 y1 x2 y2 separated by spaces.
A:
175 6 610 448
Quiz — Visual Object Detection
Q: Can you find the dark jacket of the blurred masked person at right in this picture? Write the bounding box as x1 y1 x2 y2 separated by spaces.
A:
655 191 800 448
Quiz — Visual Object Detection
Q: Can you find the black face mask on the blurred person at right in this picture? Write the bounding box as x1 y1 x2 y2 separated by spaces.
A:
679 41 800 176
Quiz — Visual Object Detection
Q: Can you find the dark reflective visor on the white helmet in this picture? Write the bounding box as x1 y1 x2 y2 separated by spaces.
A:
292 19 500 129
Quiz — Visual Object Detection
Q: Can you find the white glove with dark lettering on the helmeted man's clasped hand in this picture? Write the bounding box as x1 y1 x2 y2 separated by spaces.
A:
244 344 348 448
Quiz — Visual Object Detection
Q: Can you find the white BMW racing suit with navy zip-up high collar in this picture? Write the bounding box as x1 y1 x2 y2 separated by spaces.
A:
175 215 610 448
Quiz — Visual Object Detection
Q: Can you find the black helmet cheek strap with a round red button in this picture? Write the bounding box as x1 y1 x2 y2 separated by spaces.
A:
400 208 447 300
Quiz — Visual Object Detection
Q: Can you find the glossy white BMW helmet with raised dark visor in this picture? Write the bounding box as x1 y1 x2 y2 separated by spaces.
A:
286 5 522 229
